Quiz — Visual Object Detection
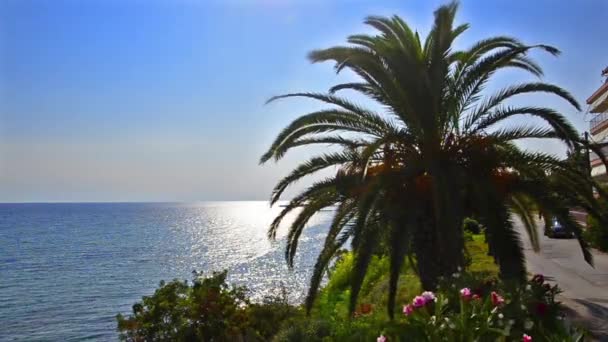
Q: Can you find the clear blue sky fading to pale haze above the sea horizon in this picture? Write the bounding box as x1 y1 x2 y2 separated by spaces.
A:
0 0 608 202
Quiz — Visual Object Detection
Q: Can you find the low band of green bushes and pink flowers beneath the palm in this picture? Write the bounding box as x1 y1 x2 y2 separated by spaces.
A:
117 243 577 342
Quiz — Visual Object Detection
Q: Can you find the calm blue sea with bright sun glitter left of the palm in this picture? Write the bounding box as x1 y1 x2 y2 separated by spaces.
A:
0 202 331 341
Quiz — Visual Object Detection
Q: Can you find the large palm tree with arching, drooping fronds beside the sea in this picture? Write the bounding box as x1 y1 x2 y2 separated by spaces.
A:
260 3 603 316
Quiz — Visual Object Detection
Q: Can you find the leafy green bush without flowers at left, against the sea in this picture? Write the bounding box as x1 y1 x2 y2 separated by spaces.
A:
116 271 300 341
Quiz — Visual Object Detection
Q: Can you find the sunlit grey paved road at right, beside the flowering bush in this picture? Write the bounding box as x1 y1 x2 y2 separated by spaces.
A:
516 221 608 341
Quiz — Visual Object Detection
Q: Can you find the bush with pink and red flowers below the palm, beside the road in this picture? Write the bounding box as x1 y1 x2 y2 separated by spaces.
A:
384 275 582 341
